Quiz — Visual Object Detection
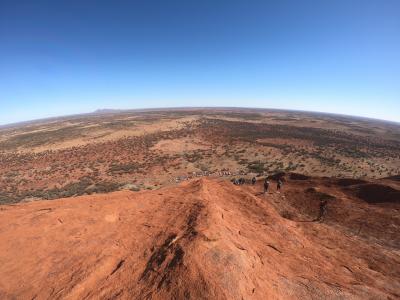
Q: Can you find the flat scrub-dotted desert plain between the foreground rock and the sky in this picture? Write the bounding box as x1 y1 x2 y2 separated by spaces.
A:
0 109 400 203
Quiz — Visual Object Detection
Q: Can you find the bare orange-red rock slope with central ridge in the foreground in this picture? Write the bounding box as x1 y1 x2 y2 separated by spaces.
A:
0 179 400 299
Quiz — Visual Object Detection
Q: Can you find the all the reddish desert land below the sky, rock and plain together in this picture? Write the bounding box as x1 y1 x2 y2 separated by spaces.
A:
0 108 400 299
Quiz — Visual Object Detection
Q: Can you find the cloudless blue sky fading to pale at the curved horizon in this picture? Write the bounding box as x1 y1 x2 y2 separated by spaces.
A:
0 0 400 124
